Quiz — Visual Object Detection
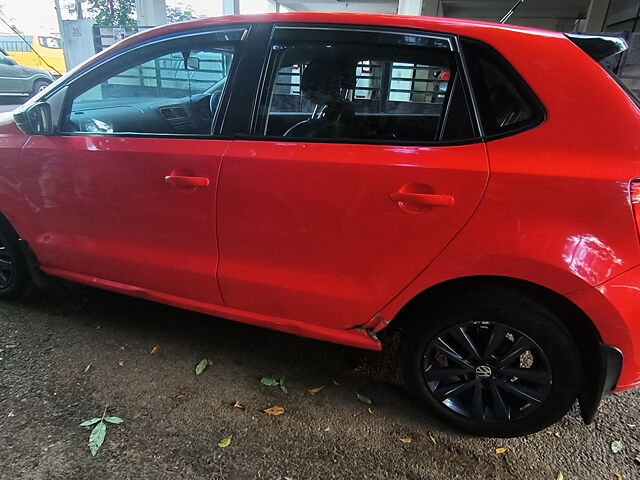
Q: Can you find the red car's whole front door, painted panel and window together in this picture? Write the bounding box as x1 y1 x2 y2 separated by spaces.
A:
22 27 245 303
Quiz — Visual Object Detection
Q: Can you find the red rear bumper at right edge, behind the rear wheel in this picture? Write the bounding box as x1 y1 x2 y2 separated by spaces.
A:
568 267 640 392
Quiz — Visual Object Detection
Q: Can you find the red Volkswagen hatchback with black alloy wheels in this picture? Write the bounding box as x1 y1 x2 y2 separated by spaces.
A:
0 13 640 436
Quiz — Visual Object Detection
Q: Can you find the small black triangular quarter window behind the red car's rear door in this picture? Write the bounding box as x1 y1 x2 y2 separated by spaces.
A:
462 39 544 136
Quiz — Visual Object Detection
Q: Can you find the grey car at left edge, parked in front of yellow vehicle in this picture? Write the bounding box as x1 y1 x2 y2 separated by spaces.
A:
0 50 53 97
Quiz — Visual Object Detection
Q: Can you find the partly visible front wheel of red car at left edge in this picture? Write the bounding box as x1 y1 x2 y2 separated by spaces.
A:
0 222 31 300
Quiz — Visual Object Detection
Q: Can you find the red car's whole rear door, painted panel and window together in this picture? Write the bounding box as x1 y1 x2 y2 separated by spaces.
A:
218 25 488 329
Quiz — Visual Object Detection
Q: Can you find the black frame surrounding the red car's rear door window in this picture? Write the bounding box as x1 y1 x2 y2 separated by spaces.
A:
238 22 483 147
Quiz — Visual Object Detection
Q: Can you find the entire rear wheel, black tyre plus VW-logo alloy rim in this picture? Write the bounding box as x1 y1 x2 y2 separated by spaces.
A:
401 288 580 437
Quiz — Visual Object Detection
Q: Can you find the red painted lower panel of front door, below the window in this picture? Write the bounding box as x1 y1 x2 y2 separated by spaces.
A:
21 136 229 303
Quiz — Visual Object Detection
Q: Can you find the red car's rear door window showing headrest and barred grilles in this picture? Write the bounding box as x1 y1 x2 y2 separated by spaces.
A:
255 28 474 143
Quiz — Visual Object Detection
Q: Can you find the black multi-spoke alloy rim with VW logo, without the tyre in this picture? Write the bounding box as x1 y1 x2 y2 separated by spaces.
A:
423 321 553 422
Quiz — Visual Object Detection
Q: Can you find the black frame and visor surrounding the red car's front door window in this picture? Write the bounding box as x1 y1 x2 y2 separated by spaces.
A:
47 24 252 140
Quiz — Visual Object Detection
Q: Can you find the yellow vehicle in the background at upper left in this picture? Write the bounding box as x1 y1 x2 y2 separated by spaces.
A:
0 33 67 77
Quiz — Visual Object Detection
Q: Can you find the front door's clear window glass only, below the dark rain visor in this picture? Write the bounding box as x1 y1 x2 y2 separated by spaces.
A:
64 49 232 135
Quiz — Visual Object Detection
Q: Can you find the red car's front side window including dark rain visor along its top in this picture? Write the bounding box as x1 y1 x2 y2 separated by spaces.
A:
62 32 242 136
